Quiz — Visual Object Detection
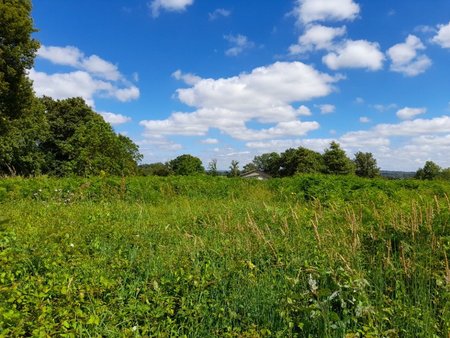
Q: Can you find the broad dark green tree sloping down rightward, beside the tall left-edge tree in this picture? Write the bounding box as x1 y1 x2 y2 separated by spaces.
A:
41 97 142 176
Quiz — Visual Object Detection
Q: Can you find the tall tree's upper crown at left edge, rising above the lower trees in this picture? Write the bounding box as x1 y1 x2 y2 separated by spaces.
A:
0 0 39 136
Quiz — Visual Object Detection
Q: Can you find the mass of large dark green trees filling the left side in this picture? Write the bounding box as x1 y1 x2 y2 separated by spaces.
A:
0 0 142 176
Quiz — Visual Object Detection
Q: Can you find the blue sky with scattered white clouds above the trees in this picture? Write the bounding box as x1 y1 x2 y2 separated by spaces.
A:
29 0 450 170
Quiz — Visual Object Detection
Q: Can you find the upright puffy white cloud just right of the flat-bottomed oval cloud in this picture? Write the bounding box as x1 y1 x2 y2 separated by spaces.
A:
387 35 432 76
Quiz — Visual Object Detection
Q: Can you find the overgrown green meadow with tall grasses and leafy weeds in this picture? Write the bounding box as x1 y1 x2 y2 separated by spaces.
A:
0 175 450 338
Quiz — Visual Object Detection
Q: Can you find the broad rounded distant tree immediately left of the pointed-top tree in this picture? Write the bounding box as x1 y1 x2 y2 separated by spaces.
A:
280 147 323 177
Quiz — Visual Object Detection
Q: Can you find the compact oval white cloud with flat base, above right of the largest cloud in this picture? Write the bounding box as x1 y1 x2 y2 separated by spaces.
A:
322 40 384 71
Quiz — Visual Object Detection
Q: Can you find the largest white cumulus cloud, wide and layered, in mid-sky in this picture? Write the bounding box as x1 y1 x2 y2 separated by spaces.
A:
140 62 339 140
